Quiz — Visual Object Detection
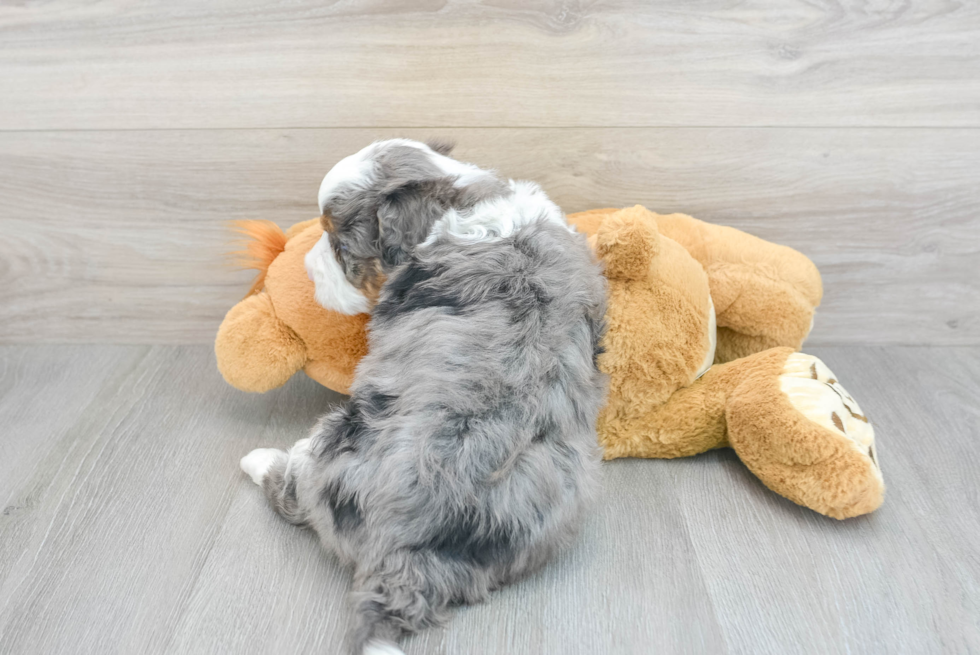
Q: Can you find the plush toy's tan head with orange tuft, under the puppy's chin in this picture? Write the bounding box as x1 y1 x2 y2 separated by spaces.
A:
215 220 368 393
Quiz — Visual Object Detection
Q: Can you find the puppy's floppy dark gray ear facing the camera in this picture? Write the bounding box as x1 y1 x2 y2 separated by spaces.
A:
378 177 457 272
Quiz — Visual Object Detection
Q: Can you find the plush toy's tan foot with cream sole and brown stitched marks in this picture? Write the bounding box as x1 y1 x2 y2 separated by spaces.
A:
725 353 885 519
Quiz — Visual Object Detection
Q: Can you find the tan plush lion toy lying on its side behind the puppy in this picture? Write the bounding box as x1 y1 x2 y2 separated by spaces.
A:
215 206 884 519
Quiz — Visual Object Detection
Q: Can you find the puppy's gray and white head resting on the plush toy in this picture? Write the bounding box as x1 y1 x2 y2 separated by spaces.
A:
306 139 497 314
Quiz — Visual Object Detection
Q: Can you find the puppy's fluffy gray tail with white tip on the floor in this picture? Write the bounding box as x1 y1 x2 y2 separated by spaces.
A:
348 550 478 655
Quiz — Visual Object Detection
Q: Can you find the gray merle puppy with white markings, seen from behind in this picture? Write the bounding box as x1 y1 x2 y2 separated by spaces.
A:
242 139 605 654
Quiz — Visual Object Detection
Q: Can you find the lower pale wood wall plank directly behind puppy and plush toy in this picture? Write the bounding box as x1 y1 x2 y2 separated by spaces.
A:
0 128 980 344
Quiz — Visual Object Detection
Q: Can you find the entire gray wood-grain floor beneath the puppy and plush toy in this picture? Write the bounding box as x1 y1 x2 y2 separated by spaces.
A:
0 346 980 655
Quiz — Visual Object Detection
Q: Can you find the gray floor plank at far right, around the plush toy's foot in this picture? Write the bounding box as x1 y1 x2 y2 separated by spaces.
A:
677 347 980 653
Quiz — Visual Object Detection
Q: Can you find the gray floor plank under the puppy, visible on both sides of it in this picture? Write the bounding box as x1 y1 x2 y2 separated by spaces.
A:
169 452 727 655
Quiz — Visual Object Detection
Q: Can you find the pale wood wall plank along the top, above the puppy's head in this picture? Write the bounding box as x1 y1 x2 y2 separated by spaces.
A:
0 0 980 130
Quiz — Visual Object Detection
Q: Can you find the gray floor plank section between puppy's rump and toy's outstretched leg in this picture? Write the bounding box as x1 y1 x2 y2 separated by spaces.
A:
405 461 730 655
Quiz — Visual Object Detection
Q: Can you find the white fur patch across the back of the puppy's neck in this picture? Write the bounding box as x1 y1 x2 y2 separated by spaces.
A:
422 180 575 245
